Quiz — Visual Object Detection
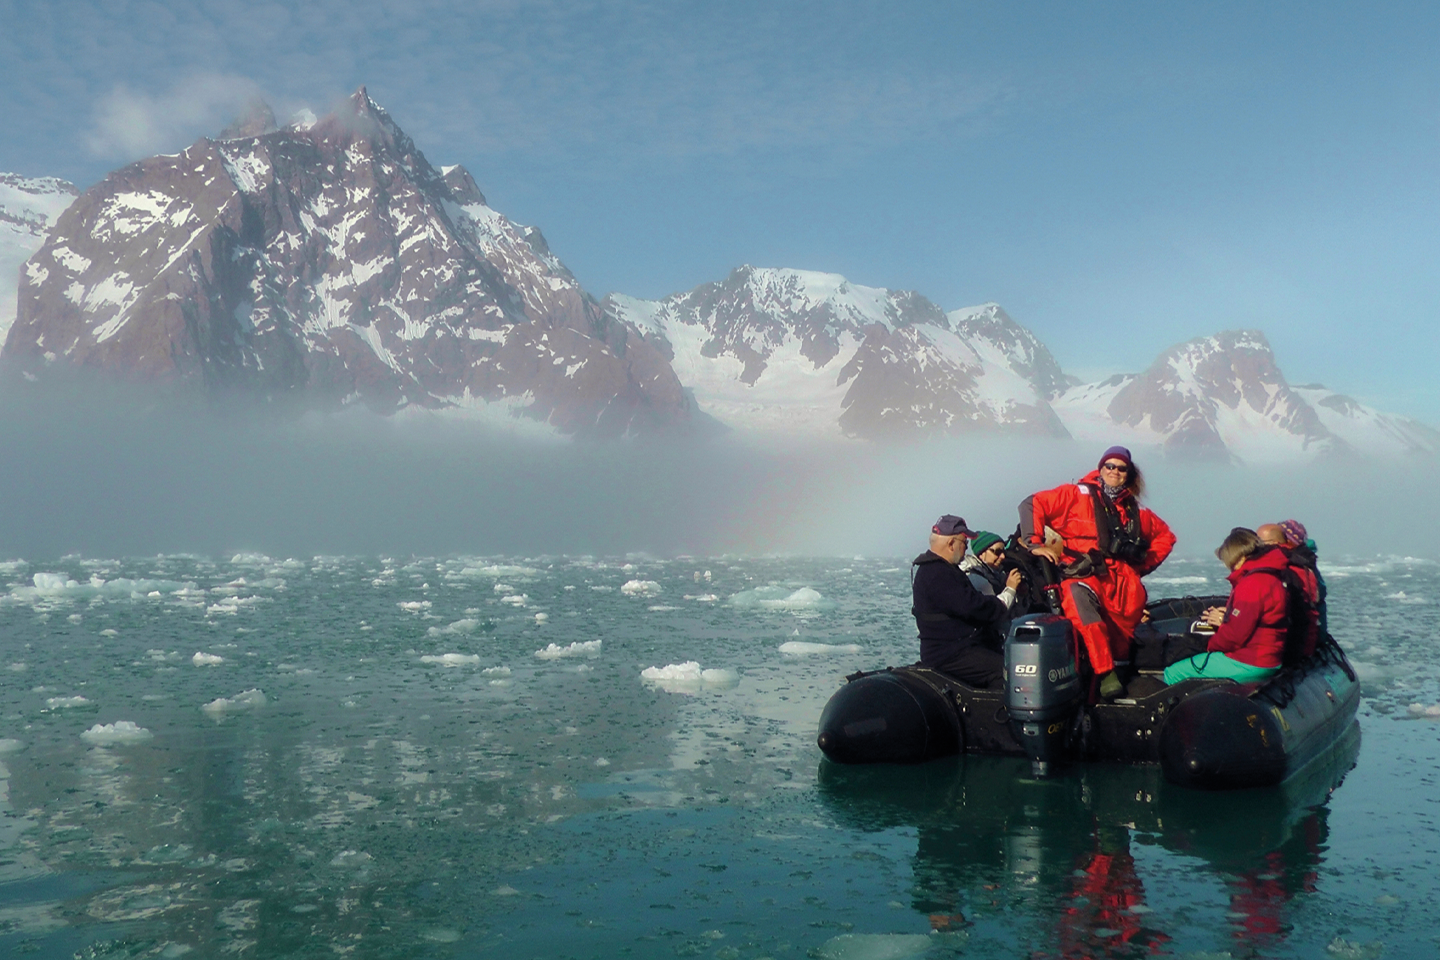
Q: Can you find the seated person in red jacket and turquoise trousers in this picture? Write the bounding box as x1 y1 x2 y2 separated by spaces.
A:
1165 527 1290 684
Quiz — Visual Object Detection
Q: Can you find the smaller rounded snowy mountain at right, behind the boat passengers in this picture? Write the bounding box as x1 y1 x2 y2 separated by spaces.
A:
1054 330 1347 463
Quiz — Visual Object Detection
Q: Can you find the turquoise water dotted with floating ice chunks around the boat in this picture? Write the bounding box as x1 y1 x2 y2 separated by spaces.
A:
0 556 1440 960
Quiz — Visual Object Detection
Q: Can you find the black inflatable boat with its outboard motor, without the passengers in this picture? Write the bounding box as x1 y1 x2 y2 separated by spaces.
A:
818 597 1359 789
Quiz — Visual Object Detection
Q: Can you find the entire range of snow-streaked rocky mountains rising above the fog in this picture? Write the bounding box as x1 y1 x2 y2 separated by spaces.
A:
0 88 1440 463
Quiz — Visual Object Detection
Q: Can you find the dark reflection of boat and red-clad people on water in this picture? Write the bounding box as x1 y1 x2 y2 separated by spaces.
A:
818 724 1359 959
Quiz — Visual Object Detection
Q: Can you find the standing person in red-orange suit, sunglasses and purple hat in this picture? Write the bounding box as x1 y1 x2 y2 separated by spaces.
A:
1020 446 1175 698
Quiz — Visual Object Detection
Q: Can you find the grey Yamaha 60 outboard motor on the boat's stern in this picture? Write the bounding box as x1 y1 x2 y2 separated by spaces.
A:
1005 613 1083 777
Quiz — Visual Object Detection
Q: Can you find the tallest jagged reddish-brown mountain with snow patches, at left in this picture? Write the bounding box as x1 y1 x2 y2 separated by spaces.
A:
3 88 691 435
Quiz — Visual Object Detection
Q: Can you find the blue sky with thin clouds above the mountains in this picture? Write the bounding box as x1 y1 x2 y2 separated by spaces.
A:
8 0 1440 422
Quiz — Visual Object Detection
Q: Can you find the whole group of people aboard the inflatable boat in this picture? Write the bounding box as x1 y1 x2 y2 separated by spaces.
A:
912 446 1328 699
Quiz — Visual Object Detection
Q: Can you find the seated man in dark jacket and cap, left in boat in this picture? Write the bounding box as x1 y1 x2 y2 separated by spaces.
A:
910 514 1020 689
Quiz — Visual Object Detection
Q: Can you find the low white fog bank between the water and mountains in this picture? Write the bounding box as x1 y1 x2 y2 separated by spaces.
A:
0 379 1440 560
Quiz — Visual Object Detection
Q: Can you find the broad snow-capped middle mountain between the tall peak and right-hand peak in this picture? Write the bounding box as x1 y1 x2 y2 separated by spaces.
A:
605 266 1064 439
